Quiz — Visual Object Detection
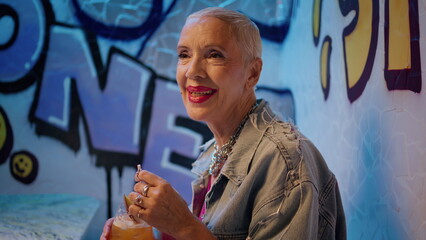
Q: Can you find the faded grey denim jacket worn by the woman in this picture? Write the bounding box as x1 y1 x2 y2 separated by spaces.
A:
192 101 346 239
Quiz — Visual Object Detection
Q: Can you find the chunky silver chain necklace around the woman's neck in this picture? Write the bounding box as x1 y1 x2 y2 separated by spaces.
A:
209 102 258 177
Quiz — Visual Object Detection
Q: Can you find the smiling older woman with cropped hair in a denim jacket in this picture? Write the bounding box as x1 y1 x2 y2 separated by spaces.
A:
101 8 346 239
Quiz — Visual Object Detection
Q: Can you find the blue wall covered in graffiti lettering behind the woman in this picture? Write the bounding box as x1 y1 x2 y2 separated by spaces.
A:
0 0 426 239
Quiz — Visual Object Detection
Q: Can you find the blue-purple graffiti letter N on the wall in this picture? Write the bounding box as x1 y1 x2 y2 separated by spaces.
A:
35 26 153 155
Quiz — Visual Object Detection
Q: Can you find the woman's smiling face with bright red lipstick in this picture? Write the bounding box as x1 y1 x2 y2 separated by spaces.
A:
176 17 253 123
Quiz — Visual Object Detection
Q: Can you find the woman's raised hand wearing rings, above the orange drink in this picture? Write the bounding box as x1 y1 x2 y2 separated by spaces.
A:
129 170 214 239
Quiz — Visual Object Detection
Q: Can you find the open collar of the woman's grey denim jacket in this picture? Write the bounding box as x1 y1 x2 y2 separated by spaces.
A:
192 100 275 185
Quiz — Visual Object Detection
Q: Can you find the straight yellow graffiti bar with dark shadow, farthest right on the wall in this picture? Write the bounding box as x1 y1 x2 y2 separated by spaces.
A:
384 0 422 93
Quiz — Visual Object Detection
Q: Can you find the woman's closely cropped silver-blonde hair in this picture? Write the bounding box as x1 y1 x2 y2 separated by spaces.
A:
186 7 262 62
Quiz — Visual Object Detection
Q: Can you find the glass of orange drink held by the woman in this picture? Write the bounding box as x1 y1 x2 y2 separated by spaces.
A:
109 204 156 240
